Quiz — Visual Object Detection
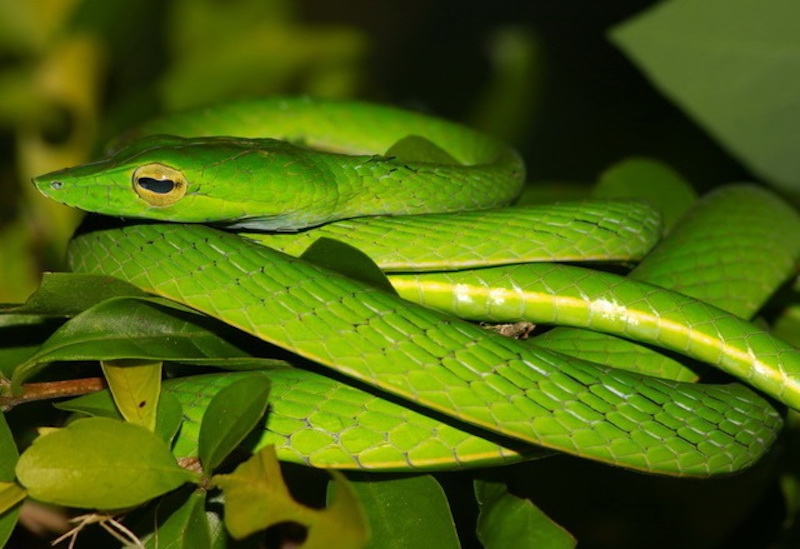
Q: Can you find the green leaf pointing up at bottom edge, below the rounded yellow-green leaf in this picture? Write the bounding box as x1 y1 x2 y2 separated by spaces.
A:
142 489 211 549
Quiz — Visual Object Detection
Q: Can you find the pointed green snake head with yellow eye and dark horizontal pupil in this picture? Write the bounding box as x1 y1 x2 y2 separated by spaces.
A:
33 135 335 230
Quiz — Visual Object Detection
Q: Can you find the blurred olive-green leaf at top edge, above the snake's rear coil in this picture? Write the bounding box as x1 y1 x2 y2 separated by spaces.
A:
160 0 367 110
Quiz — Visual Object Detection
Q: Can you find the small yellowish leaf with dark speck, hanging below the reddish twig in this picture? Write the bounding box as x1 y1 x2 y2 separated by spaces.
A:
100 360 162 431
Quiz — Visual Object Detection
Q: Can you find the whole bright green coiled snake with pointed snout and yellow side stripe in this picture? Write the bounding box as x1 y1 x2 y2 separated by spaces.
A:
29 98 800 475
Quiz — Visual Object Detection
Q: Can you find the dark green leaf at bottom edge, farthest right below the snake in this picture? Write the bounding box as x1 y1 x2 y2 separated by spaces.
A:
475 480 576 549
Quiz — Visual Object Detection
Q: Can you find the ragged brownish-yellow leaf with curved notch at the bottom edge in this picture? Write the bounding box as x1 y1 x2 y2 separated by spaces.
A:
212 446 369 549
